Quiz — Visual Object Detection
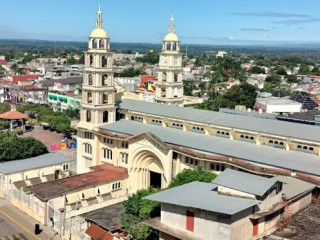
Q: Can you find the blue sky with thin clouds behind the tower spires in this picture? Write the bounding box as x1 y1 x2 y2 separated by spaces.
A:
0 0 320 45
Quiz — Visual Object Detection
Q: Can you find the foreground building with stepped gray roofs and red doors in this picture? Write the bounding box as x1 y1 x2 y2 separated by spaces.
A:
145 169 315 240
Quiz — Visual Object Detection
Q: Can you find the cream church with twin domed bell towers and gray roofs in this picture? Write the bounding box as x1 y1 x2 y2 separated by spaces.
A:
77 8 320 197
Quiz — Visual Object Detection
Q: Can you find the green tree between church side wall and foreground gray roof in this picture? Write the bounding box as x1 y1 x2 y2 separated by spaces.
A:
169 167 217 188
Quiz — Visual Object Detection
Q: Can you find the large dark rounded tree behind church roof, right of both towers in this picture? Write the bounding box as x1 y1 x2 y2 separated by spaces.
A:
221 82 257 108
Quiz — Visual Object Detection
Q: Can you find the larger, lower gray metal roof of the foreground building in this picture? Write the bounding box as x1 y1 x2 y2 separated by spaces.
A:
144 182 260 215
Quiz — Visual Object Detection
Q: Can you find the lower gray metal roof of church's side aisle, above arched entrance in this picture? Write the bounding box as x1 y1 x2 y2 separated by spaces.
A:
101 120 320 176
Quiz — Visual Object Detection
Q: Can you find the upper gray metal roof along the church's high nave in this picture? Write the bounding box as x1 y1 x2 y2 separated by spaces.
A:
117 99 320 142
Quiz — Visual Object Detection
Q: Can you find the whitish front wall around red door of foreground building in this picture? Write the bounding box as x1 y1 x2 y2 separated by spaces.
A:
161 203 230 240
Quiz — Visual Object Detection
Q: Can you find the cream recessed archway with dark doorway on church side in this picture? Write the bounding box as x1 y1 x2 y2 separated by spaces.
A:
130 150 167 191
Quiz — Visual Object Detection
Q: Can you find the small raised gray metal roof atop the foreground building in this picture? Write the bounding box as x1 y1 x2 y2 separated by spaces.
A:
212 169 277 196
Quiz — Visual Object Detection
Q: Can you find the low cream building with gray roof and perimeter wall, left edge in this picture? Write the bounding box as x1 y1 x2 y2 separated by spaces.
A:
0 153 72 223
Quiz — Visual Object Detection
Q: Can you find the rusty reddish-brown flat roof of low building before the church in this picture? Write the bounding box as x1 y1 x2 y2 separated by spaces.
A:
27 163 129 202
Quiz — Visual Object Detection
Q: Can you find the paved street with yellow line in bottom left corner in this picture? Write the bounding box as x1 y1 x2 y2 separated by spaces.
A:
0 198 61 240
